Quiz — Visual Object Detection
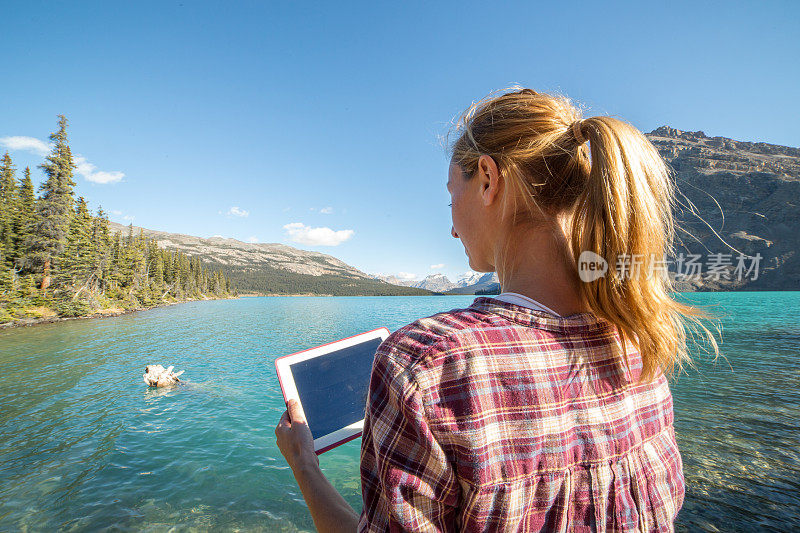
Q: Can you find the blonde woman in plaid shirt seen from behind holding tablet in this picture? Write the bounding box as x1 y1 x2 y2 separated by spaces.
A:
276 89 717 531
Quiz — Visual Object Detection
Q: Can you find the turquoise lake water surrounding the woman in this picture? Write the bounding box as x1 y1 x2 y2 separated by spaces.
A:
0 292 800 531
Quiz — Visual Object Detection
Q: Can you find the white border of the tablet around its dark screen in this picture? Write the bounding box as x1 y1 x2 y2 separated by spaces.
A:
275 328 390 454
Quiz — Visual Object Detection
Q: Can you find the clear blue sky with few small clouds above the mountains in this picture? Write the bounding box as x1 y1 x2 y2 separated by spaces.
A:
0 0 800 278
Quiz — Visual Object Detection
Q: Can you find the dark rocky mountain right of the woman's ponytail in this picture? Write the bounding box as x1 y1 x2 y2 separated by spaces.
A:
647 126 800 291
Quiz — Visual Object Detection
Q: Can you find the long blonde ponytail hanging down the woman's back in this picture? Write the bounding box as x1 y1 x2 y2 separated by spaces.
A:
571 117 718 380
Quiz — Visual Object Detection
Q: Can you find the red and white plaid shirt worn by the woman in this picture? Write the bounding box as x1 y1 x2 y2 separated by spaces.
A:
359 297 685 531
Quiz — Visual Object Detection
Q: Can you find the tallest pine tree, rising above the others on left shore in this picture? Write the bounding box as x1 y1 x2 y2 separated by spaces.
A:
27 115 75 290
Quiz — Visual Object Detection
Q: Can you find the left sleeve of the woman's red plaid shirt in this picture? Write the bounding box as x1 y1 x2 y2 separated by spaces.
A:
358 338 461 532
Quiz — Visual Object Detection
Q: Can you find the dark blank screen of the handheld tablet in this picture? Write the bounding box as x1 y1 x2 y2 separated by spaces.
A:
291 338 382 439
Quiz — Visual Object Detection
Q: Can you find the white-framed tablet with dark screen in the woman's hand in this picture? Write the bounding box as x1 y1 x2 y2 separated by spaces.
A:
275 328 389 455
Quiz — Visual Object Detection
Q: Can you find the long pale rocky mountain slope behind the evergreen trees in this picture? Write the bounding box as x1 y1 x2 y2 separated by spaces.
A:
109 222 430 296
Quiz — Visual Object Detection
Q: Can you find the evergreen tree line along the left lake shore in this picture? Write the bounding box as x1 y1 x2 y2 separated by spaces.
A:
0 115 236 322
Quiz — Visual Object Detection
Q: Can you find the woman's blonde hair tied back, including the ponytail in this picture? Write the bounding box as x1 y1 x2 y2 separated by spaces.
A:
452 87 719 382
